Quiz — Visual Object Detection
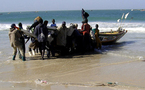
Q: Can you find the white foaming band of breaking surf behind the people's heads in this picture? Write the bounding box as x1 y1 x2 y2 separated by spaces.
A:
0 22 145 33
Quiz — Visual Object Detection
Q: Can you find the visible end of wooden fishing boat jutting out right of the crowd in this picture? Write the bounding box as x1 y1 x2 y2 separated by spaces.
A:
99 30 127 44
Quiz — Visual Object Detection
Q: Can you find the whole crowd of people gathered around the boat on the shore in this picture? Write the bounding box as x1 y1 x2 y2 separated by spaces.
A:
9 8 101 61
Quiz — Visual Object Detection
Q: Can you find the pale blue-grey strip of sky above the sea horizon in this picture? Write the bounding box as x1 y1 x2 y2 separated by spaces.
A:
0 0 145 12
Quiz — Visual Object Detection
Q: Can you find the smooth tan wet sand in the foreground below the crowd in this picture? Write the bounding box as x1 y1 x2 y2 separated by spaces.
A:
0 52 145 90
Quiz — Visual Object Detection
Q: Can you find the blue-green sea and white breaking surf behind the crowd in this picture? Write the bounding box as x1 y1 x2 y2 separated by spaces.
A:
0 10 145 31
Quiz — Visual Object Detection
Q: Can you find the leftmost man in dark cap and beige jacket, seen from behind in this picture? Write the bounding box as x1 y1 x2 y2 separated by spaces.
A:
9 24 26 61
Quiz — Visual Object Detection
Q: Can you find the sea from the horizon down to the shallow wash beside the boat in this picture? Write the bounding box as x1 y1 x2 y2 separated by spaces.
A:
0 10 145 62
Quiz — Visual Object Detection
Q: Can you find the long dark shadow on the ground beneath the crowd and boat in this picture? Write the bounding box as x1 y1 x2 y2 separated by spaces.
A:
27 41 135 61
